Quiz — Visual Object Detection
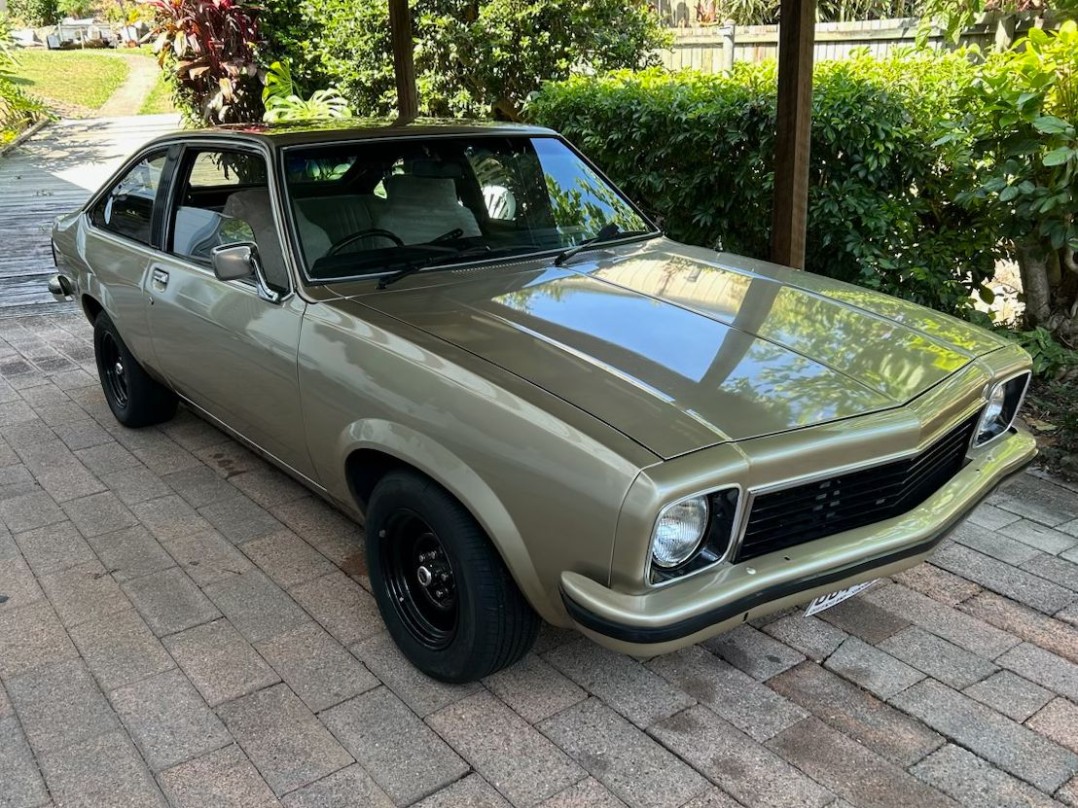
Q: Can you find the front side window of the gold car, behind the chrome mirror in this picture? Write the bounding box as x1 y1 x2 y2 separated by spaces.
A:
169 150 289 291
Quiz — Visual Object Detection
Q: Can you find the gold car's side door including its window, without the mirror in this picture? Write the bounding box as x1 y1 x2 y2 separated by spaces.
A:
146 148 314 477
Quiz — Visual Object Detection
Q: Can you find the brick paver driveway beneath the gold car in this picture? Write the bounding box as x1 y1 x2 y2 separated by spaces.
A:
0 315 1078 808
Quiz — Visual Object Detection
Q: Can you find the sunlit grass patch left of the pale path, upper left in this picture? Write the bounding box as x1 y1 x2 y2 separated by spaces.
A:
8 51 129 110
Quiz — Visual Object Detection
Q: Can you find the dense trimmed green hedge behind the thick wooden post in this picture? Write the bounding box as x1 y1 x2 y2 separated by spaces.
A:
527 53 998 315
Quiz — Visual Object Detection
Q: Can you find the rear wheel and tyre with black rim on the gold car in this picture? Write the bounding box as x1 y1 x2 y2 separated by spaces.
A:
94 311 178 428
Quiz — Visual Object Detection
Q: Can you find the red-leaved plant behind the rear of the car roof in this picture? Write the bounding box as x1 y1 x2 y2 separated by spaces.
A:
144 0 262 124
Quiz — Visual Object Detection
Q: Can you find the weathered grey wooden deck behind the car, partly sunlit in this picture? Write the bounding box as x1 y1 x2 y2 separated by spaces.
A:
0 115 179 317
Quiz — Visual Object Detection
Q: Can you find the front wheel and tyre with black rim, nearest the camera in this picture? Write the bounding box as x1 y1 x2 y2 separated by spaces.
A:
367 471 539 683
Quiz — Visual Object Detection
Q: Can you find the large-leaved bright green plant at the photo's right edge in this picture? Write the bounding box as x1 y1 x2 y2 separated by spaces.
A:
938 22 1078 346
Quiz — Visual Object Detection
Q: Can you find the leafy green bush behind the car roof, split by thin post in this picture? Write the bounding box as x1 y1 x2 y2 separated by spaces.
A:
264 0 667 120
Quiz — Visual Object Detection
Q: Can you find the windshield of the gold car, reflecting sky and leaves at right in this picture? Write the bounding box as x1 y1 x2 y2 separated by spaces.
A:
285 136 654 282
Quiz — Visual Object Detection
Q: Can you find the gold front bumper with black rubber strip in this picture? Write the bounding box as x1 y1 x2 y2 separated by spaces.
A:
561 431 1037 656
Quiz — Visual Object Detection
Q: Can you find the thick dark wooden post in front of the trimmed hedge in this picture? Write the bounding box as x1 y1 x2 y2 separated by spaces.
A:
771 0 816 269
